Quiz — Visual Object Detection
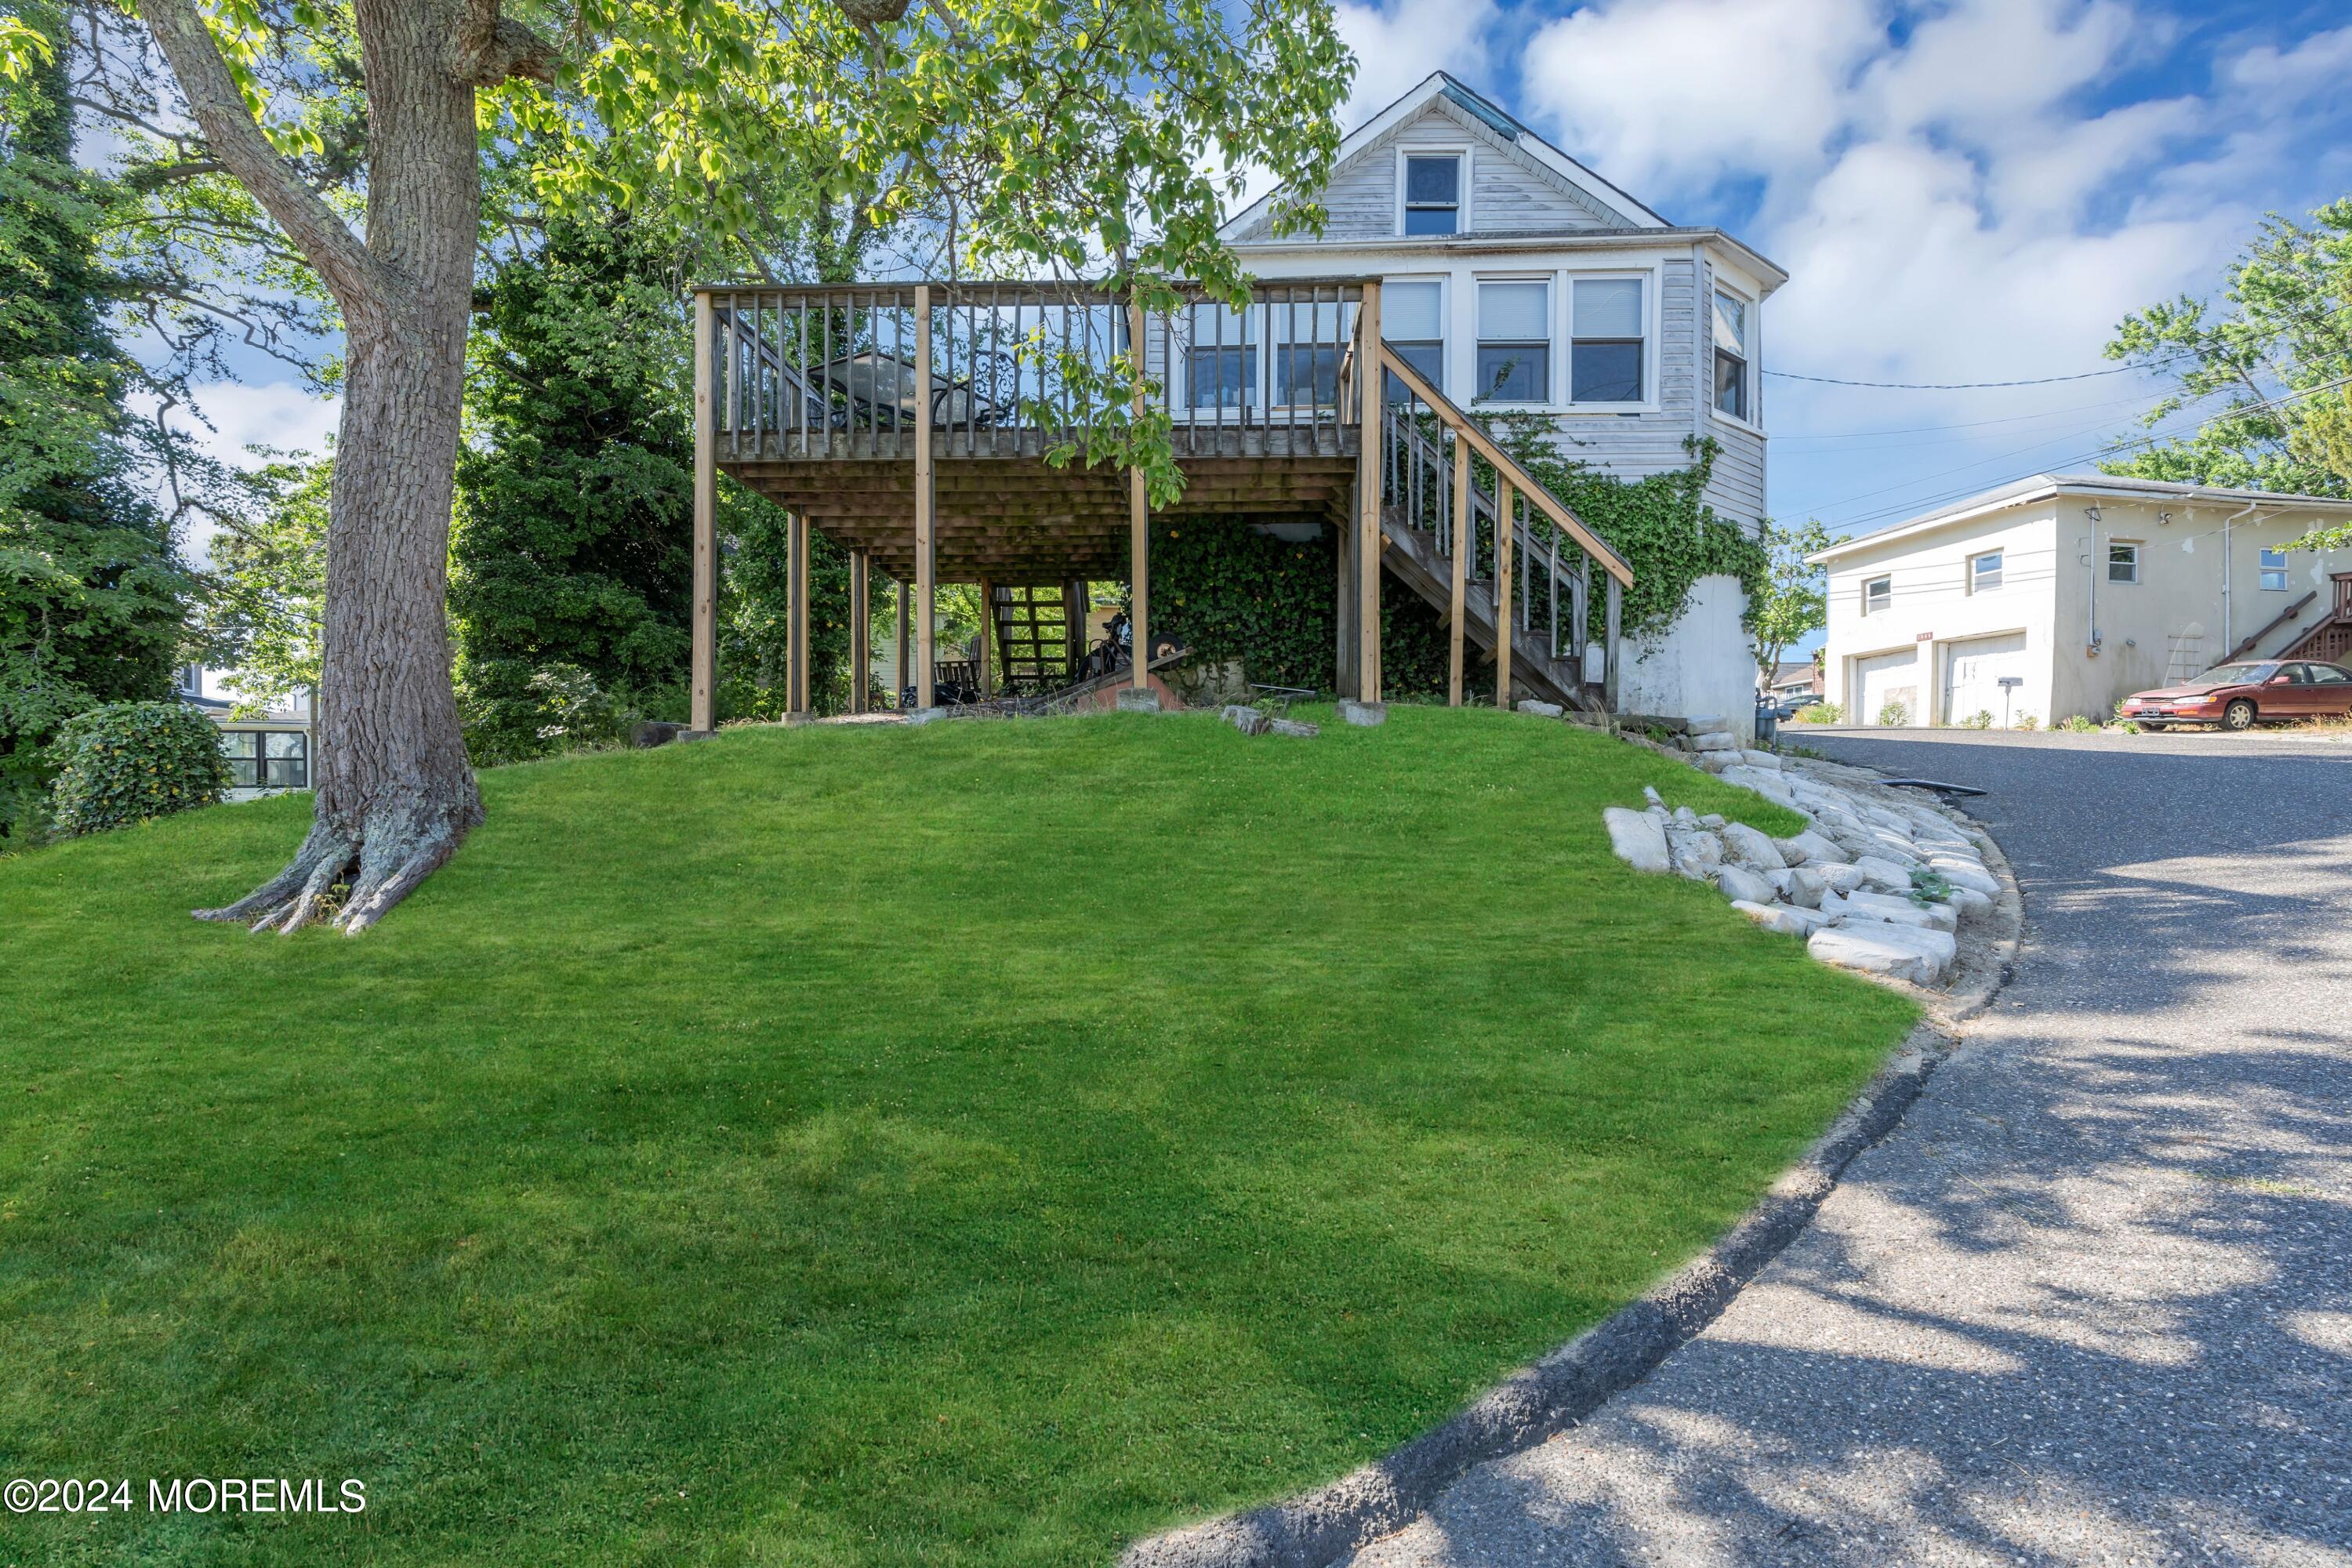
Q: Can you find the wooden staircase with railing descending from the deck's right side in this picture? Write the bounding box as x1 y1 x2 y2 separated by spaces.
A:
1378 346 1632 715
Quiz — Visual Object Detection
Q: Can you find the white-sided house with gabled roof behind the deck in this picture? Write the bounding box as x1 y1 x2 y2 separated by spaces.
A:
1223 71 1788 727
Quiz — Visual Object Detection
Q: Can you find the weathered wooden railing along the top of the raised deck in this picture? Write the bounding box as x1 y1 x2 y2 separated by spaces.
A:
703 278 1364 461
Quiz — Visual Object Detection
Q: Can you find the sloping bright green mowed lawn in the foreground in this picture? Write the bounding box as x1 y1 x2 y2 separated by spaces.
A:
0 708 1912 1568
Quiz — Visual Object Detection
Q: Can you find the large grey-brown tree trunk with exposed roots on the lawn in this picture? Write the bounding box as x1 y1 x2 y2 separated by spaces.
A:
141 0 529 933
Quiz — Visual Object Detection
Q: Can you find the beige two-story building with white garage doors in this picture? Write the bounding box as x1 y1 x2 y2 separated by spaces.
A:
1811 475 2352 724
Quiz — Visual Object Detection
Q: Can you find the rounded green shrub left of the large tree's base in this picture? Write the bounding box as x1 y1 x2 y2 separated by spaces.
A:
49 703 228 837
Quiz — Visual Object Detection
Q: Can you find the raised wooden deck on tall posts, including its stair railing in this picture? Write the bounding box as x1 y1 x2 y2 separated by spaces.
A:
694 278 1630 729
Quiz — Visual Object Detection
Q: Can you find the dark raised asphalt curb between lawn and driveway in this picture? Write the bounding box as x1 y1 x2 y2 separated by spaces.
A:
1117 813 2025 1568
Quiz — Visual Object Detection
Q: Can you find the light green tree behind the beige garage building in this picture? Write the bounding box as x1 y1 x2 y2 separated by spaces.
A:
2103 198 2352 521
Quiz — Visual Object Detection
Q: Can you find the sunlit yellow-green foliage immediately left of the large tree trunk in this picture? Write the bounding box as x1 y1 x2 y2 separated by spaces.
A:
198 459 334 708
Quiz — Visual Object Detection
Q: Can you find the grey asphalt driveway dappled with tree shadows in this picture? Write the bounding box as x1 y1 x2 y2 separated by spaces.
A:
1355 731 2352 1568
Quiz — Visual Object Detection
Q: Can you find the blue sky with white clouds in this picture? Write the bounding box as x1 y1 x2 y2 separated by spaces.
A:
170 0 2352 571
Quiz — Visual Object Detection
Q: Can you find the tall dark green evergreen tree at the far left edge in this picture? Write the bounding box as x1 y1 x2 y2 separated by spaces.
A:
0 12 191 837
